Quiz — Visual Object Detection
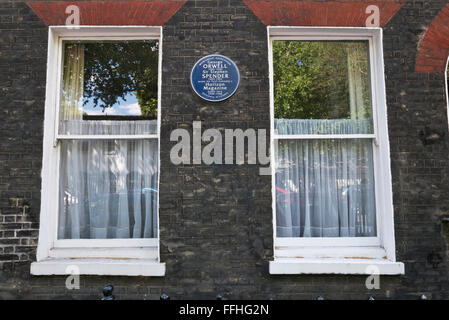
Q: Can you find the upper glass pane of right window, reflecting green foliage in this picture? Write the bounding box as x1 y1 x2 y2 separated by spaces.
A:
273 40 374 134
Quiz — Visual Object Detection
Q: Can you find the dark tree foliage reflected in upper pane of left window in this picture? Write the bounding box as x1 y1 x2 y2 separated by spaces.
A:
84 41 158 117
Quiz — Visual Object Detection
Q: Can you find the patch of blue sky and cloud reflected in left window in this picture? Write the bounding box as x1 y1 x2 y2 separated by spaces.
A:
80 92 142 116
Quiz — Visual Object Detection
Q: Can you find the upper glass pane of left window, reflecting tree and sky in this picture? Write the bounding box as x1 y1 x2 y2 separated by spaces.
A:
59 40 159 135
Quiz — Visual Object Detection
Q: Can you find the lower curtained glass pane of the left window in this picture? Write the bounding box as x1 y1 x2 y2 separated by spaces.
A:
58 140 158 239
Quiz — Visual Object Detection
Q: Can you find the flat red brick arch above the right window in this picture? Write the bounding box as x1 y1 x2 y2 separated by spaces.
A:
243 0 405 27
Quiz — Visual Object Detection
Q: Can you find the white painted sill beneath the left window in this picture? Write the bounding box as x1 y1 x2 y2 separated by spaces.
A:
31 259 165 277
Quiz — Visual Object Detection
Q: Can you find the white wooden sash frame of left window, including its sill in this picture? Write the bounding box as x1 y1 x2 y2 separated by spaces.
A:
31 26 165 276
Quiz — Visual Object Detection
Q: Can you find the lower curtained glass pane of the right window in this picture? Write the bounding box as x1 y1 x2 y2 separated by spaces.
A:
276 139 376 237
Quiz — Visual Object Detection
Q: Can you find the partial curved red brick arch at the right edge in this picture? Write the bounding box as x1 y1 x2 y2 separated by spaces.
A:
415 4 449 73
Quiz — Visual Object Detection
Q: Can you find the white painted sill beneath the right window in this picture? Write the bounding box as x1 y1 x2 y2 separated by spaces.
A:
270 258 405 275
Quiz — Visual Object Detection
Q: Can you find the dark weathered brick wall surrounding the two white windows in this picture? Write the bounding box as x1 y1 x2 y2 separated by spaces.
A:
0 0 449 299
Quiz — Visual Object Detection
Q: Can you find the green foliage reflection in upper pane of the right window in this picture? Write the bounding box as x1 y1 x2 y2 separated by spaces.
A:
273 41 370 119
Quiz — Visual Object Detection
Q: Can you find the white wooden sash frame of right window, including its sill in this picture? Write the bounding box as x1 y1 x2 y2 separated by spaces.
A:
267 26 404 274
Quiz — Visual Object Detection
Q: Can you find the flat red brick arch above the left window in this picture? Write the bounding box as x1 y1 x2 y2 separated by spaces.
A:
27 0 186 26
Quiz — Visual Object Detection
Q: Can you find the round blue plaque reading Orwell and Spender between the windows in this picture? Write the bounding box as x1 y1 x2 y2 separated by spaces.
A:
190 54 240 102
